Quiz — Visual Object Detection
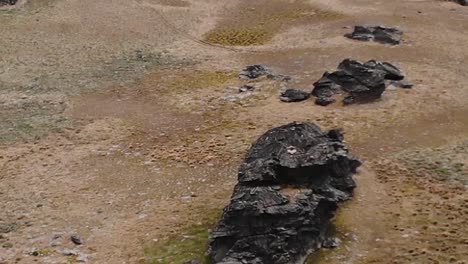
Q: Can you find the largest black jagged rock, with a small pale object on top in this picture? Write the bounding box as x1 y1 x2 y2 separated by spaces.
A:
209 123 361 264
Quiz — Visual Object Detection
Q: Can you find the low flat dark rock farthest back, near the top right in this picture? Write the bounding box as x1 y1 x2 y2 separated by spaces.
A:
345 26 403 45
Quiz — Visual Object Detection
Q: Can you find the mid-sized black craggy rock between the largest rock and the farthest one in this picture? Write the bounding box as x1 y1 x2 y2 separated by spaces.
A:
312 59 405 105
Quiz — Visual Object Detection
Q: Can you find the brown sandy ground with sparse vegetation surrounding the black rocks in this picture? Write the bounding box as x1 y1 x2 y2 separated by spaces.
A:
0 0 468 264
